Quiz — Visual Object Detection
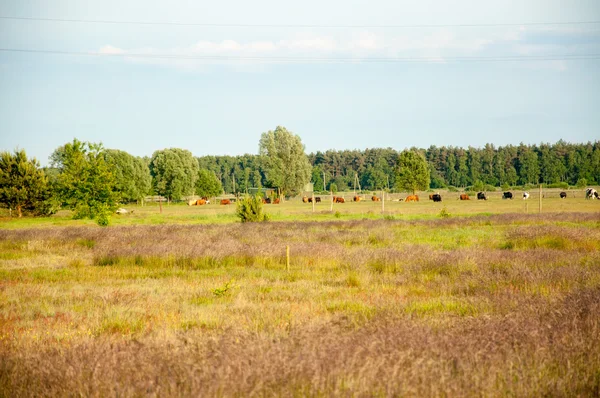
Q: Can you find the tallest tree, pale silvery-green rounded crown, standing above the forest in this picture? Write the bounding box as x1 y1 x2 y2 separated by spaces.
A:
259 126 312 195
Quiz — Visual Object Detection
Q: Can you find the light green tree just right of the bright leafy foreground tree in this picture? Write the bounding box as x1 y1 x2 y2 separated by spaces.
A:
104 149 152 202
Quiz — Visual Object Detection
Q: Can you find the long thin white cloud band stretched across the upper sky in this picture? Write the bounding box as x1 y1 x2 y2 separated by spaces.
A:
90 26 584 69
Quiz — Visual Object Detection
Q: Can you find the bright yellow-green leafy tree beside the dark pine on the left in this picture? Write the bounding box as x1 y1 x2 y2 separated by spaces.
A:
50 139 119 219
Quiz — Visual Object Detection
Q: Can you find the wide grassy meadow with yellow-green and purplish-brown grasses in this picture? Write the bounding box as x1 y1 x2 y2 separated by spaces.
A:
0 192 600 396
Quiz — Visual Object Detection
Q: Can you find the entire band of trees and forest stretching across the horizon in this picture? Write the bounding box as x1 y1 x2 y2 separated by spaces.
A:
0 126 600 223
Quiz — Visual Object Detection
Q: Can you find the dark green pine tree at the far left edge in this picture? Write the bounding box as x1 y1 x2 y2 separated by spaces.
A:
0 150 51 217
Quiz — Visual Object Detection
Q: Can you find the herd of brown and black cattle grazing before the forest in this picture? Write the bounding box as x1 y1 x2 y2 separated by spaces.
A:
188 188 600 206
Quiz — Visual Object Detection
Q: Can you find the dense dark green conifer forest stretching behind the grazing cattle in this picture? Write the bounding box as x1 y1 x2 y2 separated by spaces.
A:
198 140 600 192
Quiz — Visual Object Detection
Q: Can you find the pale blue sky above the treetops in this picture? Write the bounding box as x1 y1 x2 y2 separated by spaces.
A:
0 0 600 165
